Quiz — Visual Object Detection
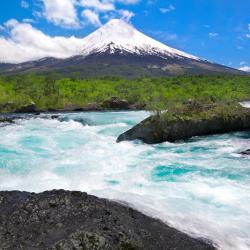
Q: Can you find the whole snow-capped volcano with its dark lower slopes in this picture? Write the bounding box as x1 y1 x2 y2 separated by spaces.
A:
0 19 242 77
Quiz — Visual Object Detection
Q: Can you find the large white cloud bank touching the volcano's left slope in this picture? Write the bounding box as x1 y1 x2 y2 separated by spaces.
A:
0 19 86 63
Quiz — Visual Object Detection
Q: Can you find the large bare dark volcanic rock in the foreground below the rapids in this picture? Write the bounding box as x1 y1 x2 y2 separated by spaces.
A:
0 190 215 250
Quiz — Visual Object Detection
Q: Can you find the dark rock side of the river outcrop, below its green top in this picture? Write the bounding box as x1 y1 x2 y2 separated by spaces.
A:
117 104 250 144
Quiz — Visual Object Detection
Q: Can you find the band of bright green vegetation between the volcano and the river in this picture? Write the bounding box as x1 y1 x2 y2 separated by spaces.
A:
0 74 250 112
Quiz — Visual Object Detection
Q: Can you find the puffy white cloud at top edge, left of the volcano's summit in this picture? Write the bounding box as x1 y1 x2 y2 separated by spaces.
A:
43 0 79 28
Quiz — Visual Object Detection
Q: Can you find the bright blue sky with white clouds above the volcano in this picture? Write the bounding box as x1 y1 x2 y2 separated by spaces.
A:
0 0 250 70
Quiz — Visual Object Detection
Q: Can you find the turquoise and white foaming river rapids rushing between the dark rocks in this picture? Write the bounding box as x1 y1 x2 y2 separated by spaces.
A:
0 112 250 250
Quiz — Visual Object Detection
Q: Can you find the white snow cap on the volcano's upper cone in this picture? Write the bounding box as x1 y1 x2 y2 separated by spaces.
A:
82 19 200 60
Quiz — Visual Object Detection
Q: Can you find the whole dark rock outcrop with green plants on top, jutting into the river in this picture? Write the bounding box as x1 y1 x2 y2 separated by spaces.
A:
117 102 250 144
